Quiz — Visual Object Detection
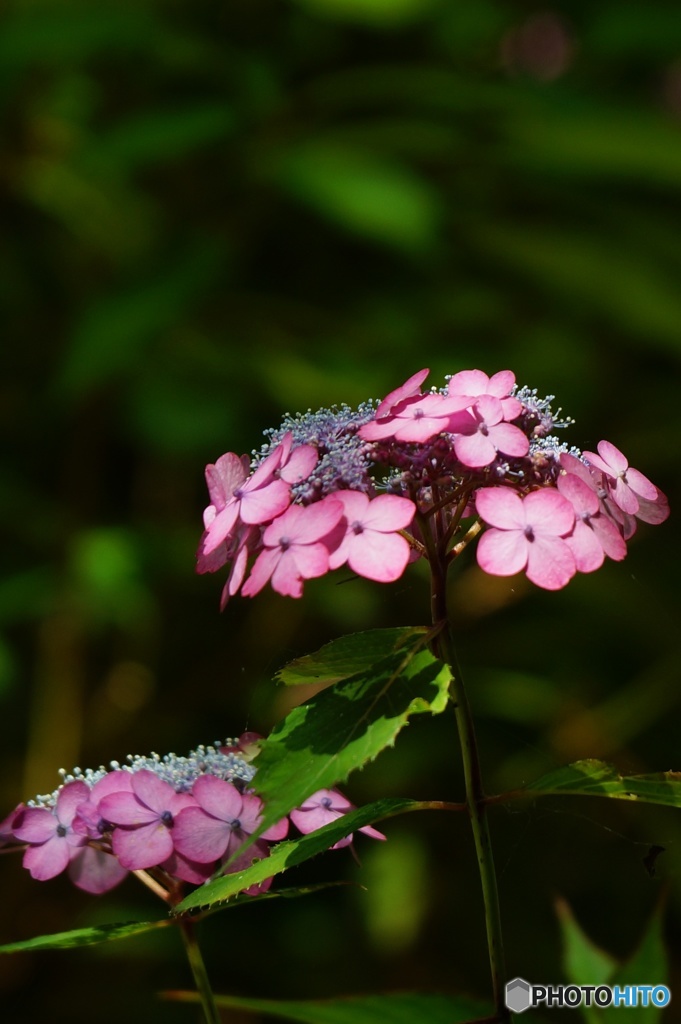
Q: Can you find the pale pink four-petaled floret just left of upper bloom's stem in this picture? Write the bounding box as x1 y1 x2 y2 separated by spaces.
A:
329 490 416 583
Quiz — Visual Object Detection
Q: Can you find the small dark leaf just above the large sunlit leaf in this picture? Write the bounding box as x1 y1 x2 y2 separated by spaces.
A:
275 626 428 686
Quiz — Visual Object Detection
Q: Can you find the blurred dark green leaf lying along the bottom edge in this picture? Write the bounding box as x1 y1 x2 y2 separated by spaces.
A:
164 992 485 1024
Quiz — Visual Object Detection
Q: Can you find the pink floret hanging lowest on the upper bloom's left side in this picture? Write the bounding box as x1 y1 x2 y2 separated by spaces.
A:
242 497 343 597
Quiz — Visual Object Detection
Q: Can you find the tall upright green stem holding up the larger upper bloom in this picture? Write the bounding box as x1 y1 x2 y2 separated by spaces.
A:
421 521 509 1021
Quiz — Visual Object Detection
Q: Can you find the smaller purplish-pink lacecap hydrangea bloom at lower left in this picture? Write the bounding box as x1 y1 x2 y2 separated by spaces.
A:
0 733 384 895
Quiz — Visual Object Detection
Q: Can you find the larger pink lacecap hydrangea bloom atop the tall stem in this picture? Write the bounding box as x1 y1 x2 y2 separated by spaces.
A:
197 370 669 607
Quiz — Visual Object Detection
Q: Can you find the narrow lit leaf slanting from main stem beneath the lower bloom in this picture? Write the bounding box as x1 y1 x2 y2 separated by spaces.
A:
175 798 419 913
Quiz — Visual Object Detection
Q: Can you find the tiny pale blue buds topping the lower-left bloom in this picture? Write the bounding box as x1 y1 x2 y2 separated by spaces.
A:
27 739 255 808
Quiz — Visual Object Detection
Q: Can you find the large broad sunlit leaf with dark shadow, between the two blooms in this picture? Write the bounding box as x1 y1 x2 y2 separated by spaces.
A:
255 650 451 829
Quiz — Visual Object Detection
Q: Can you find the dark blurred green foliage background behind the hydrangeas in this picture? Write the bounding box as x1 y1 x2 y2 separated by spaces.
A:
0 0 681 1024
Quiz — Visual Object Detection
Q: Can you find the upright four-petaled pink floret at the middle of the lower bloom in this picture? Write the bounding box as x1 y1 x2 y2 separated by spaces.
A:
99 768 195 870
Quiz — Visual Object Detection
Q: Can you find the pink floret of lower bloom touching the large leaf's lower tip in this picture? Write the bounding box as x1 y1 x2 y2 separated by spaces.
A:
174 775 289 864
